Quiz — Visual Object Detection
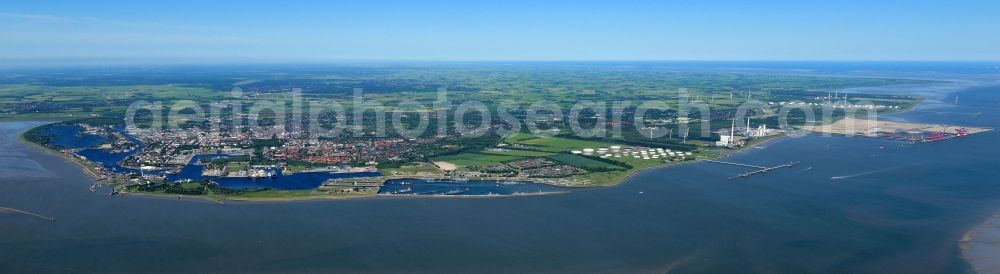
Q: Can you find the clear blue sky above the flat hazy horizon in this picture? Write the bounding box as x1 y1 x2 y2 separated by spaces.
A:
0 0 1000 61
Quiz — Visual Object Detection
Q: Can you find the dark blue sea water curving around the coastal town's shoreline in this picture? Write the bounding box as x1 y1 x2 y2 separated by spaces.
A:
0 84 1000 273
